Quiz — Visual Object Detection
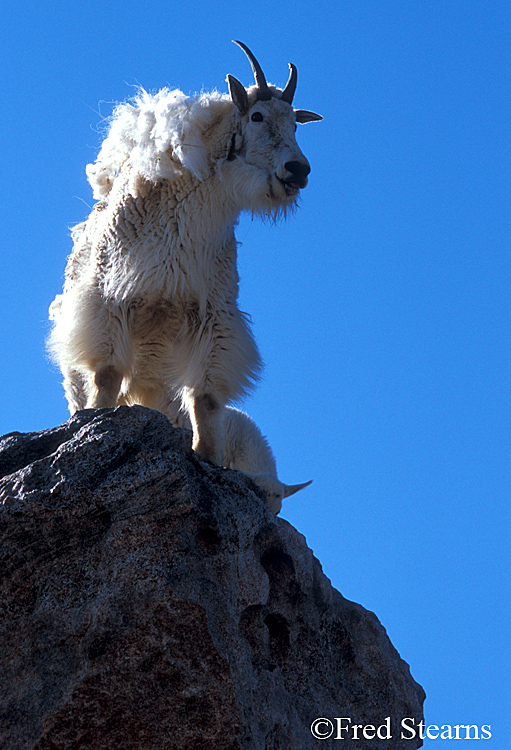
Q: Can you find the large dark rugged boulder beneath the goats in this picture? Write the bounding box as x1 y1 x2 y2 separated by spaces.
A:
0 406 424 750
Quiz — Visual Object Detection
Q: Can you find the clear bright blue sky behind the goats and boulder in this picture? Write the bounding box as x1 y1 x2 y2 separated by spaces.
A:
0 0 511 750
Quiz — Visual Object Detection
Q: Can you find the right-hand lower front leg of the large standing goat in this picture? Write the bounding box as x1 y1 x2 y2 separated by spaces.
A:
187 393 225 466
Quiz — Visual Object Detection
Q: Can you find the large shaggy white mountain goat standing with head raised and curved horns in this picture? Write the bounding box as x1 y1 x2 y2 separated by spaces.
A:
48 42 322 512
